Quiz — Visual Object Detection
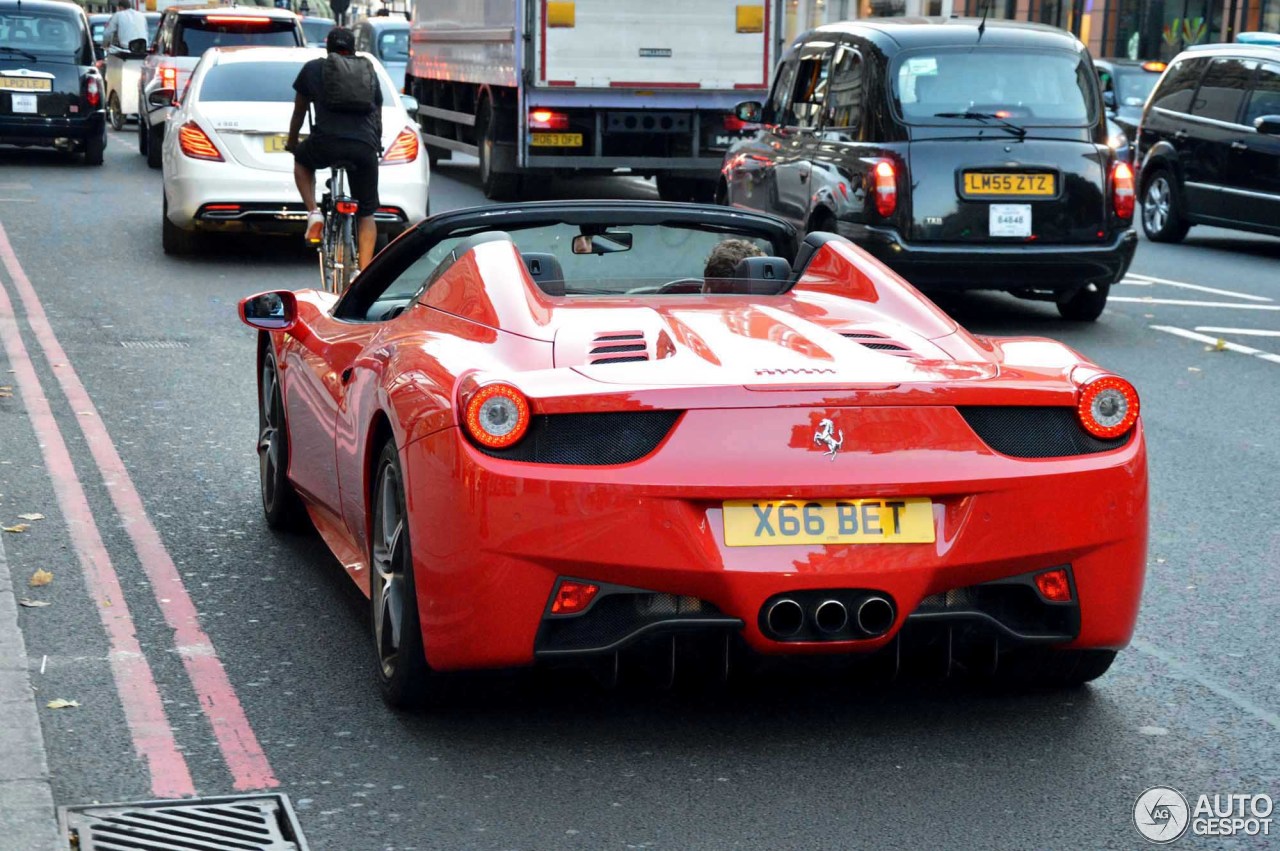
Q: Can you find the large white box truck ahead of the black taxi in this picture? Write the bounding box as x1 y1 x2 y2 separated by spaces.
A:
404 0 781 201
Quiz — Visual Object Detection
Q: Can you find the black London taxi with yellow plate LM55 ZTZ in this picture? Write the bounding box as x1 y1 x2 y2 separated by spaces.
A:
717 18 1137 320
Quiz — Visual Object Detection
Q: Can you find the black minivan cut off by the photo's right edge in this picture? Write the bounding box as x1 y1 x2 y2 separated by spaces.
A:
1137 44 1280 242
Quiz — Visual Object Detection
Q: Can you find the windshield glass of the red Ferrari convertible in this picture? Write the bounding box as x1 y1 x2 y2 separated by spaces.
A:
379 223 781 301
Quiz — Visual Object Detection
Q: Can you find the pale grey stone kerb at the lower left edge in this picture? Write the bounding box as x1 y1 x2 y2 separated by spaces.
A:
0 527 67 851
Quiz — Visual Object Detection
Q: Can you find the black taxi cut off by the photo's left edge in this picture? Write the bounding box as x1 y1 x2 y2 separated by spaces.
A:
0 0 106 165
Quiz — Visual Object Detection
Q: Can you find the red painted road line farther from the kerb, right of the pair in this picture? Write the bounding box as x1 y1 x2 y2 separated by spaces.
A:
0 225 279 791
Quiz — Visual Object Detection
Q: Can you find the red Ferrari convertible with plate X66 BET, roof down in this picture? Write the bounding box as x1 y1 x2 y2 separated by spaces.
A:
241 202 1147 705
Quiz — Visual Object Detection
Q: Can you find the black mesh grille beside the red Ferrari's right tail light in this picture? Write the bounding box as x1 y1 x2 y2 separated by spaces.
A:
956 406 1132 458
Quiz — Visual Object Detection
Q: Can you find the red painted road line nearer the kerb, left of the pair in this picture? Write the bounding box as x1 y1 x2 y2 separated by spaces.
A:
0 266 196 797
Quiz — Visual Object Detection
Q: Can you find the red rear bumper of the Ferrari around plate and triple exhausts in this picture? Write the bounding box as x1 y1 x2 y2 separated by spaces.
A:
403 407 1147 669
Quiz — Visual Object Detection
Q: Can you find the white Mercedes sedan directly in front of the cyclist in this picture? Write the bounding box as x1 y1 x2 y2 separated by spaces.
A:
151 47 430 255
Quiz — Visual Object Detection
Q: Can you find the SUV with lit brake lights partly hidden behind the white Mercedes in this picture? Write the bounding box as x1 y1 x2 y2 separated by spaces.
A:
138 6 307 169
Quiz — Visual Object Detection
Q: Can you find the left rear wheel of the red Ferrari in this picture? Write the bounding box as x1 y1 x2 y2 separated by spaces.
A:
369 440 434 709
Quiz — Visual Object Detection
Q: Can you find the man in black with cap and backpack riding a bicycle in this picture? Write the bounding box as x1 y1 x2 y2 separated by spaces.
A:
284 27 383 269
